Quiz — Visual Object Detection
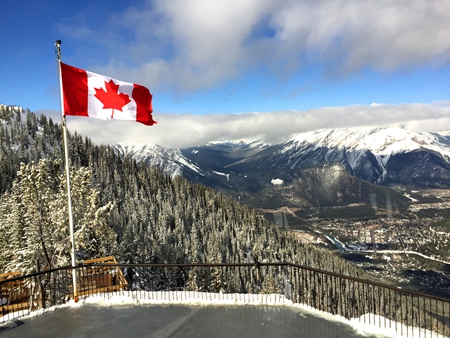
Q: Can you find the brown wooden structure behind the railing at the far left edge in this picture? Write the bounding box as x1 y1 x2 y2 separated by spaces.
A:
0 271 31 316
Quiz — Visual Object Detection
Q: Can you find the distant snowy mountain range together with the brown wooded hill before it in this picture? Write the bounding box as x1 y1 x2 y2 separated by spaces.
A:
111 127 450 207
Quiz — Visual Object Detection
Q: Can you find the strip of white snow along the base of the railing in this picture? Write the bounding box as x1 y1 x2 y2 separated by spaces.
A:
0 291 443 338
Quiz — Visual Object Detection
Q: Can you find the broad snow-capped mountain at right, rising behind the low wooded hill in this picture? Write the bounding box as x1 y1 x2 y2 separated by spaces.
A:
237 128 450 186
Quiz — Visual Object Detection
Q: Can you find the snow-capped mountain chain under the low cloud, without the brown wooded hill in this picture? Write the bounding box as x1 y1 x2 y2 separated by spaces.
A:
116 127 450 191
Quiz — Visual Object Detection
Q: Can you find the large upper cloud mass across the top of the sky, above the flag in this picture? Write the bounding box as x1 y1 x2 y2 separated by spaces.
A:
57 0 450 92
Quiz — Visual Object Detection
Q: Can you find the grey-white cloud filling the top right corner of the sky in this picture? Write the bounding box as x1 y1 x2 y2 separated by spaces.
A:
272 0 450 72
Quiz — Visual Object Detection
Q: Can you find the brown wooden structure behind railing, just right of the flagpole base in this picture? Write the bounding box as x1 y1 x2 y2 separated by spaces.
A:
78 256 128 296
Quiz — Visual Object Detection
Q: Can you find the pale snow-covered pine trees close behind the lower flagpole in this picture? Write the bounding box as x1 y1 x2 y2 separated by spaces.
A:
0 160 116 273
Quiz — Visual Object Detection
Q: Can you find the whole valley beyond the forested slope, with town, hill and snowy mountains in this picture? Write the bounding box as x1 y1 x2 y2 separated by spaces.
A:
116 128 450 297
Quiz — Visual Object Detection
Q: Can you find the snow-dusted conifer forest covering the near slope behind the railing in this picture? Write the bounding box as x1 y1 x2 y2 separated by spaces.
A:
0 105 364 277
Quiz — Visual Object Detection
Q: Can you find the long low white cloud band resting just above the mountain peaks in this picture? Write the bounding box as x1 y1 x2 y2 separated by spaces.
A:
37 104 450 148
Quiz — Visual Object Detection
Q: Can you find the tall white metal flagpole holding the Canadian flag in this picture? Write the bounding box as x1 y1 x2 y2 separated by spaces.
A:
55 40 78 302
